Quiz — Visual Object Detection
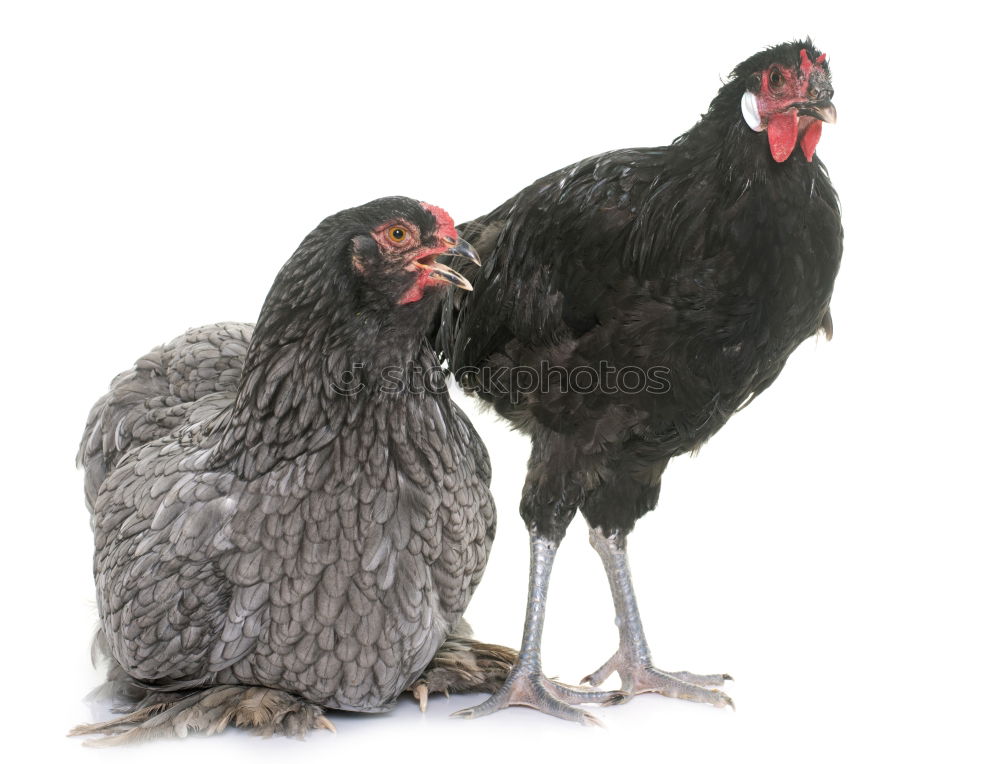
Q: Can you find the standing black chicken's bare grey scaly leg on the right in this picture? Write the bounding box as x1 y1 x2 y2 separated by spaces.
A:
582 528 733 706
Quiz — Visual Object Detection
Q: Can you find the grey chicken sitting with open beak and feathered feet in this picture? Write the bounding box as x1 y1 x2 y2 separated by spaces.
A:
77 197 513 742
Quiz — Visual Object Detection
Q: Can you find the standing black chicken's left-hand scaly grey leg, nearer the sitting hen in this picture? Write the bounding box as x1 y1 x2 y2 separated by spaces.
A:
454 533 624 724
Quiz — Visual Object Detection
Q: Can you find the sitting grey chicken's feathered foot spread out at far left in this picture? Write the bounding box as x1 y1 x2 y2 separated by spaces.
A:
69 685 336 747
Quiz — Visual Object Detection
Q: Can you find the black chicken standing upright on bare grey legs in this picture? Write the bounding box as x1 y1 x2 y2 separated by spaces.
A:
436 40 843 722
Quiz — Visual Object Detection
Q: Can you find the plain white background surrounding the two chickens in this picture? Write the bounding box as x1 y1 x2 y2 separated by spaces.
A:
0 0 1000 762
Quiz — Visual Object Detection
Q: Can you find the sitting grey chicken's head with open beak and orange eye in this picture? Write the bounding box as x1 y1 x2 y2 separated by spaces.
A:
344 196 479 305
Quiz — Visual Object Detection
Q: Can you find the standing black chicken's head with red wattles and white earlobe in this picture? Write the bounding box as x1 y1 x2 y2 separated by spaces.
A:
733 39 837 162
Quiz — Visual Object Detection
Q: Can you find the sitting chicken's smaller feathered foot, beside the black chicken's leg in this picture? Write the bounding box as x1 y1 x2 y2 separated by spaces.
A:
409 636 517 711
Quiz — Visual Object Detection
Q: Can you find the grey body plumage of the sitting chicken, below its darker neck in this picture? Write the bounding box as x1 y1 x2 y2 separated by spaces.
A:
81 324 495 711
